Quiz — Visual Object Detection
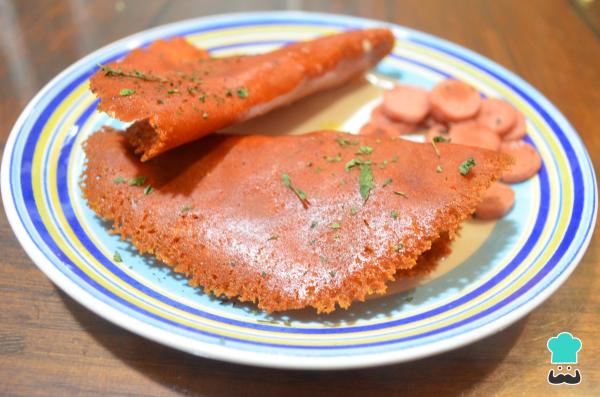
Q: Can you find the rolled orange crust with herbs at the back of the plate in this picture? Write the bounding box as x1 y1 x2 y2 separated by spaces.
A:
90 29 394 161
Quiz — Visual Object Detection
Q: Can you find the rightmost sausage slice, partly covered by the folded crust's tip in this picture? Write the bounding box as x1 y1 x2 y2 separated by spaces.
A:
500 140 542 183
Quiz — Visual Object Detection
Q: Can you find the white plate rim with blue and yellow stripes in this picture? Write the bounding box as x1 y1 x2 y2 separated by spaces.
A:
1 12 597 369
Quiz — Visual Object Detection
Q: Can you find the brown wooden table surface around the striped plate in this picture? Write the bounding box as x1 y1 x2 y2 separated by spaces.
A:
0 0 600 396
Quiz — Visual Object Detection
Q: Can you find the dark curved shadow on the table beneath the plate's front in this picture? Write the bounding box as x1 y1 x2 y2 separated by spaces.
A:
59 291 527 397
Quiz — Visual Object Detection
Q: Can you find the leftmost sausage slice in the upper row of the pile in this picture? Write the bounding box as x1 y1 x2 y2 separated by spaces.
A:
383 85 430 124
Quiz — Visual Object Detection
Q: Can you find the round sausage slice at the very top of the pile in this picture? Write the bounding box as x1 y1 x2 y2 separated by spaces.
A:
429 79 481 121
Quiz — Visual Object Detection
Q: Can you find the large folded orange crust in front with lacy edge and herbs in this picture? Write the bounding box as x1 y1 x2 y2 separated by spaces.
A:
82 129 511 312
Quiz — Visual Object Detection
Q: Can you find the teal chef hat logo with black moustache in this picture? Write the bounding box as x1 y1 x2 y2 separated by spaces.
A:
546 332 583 385
